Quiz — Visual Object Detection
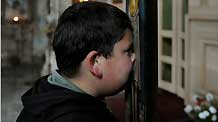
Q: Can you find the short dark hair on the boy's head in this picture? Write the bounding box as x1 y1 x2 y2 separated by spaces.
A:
53 2 133 77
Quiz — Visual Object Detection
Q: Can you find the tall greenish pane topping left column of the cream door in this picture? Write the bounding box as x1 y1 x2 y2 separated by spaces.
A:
162 0 172 30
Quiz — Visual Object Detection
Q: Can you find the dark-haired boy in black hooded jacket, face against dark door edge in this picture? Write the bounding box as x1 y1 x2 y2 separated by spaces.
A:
17 2 135 122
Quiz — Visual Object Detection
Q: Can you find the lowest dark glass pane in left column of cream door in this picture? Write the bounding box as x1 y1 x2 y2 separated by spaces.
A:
162 63 172 83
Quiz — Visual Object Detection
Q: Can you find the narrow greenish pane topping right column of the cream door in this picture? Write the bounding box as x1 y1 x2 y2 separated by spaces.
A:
182 0 188 32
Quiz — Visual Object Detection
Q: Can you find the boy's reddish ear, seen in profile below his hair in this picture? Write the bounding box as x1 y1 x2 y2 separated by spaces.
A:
86 51 102 78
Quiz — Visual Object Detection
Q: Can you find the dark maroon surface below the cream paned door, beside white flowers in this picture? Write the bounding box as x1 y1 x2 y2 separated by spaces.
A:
157 89 193 122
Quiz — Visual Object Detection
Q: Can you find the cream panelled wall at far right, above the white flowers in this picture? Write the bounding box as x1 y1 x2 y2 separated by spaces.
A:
185 0 218 102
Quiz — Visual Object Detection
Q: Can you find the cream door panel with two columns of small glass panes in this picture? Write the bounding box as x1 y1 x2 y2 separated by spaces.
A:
158 0 188 97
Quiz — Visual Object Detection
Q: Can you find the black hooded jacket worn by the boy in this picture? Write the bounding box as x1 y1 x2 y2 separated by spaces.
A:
17 76 116 122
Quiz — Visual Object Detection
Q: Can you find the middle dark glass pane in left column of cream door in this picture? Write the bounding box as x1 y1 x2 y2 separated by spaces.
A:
162 38 172 56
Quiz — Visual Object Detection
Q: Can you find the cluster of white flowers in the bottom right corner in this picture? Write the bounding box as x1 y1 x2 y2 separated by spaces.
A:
184 93 218 122
